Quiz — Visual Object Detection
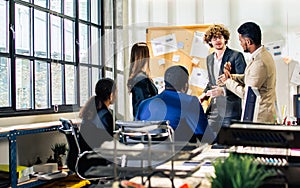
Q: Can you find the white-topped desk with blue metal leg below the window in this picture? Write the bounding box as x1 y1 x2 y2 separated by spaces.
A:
0 121 61 187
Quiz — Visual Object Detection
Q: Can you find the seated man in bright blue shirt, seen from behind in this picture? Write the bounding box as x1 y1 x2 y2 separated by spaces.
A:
135 66 207 142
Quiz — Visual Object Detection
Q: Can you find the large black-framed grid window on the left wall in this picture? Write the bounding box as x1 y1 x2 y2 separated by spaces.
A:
0 0 105 117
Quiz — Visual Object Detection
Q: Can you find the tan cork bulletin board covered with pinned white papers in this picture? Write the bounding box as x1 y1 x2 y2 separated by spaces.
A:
146 25 211 96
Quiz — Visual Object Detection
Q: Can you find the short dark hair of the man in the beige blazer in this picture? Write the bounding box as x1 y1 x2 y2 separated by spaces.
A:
237 22 261 45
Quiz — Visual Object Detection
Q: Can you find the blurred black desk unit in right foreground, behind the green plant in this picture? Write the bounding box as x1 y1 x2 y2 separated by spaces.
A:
217 123 300 187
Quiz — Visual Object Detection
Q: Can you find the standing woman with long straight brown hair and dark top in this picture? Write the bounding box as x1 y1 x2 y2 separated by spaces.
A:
127 42 158 117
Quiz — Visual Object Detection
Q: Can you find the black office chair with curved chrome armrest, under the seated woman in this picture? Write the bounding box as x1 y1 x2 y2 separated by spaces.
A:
59 118 114 183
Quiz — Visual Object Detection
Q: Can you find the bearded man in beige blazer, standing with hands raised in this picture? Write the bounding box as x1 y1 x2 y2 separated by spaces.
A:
220 22 276 123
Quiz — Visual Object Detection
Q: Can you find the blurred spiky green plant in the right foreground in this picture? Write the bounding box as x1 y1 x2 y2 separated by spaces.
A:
210 154 276 188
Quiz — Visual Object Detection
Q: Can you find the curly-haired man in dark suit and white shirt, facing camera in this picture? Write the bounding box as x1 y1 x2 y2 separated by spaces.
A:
199 25 246 141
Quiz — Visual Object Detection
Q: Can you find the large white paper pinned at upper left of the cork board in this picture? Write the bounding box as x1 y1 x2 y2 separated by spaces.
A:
151 34 178 56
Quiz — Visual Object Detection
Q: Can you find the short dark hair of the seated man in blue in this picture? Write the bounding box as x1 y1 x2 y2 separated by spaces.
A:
164 65 189 91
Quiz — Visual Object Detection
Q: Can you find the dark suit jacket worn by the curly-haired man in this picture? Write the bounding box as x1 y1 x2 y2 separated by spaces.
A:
204 47 246 119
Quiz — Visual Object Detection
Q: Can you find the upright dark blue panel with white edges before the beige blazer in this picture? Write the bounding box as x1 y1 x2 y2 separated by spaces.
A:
241 86 260 122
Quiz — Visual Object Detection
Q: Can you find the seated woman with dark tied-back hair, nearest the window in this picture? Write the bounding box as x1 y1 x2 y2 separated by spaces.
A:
79 78 116 150
